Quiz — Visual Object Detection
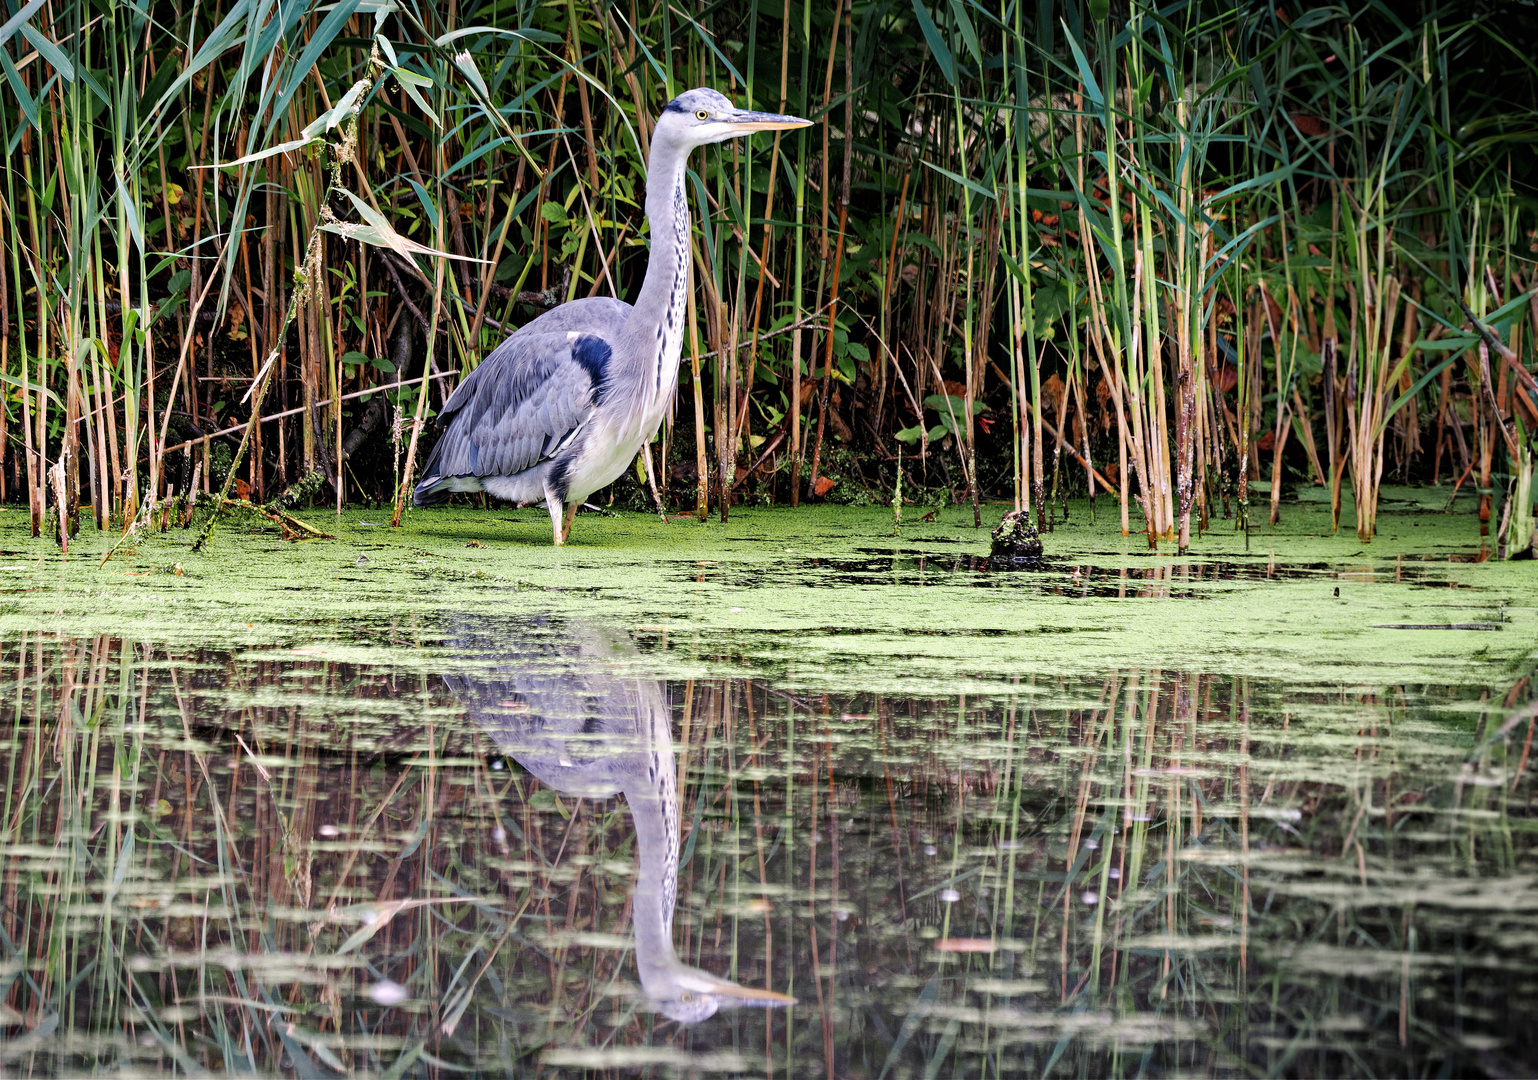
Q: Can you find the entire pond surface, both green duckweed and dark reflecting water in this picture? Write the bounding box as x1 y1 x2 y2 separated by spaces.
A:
0 509 1538 1078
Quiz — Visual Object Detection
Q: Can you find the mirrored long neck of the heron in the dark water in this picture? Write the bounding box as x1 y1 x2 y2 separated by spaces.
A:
624 702 678 986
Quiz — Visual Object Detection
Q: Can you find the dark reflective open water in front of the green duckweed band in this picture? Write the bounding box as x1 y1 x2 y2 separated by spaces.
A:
0 630 1538 1077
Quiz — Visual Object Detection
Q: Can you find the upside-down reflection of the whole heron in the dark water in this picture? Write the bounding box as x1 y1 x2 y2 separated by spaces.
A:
443 620 795 1023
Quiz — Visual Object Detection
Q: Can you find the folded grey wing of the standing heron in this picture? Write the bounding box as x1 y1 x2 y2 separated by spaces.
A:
423 331 611 480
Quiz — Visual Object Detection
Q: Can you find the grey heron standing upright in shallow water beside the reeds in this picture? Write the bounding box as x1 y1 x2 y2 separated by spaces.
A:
412 89 811 545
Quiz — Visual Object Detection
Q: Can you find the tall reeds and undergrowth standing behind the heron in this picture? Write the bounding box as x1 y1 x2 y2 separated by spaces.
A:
0 0 1538 555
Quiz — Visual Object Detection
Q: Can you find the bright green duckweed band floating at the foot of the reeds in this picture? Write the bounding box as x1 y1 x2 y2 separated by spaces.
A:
0 491 1538 688
